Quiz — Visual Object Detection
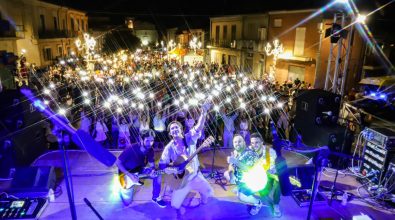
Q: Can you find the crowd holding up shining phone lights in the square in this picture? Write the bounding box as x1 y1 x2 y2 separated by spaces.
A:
2 50 311 149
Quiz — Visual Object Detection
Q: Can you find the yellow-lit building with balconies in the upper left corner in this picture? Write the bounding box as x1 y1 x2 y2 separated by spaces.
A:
0 0 88 67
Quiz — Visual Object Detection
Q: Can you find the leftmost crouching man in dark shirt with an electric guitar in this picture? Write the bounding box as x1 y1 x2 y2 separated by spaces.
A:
115 129 166 208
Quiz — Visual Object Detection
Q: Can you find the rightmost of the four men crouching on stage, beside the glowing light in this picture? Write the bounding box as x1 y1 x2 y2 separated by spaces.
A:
238 133 281 217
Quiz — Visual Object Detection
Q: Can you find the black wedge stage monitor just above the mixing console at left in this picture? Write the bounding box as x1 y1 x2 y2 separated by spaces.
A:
9 166 56 193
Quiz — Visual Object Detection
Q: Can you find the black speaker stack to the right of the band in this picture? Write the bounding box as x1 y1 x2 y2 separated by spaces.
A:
294 89 351 168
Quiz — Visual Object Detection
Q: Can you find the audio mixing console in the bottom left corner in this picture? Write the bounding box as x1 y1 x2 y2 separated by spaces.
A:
0 198 48 219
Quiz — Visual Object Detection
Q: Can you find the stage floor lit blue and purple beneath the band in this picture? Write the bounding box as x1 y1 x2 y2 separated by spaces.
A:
17 150 392 220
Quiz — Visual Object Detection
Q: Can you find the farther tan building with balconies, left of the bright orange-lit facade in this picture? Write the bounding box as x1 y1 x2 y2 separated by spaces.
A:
207 14 268 78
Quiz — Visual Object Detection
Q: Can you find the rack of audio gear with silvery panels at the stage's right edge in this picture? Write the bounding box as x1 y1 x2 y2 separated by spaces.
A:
361 128 395 185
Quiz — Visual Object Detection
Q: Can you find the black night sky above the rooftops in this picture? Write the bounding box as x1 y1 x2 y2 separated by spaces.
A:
46 0 395 34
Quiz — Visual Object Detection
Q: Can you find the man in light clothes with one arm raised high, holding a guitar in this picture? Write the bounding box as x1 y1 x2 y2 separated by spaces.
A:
159 102 214 215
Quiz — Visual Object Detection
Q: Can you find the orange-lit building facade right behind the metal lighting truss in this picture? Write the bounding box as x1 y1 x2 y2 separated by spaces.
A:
266 9 364 90
